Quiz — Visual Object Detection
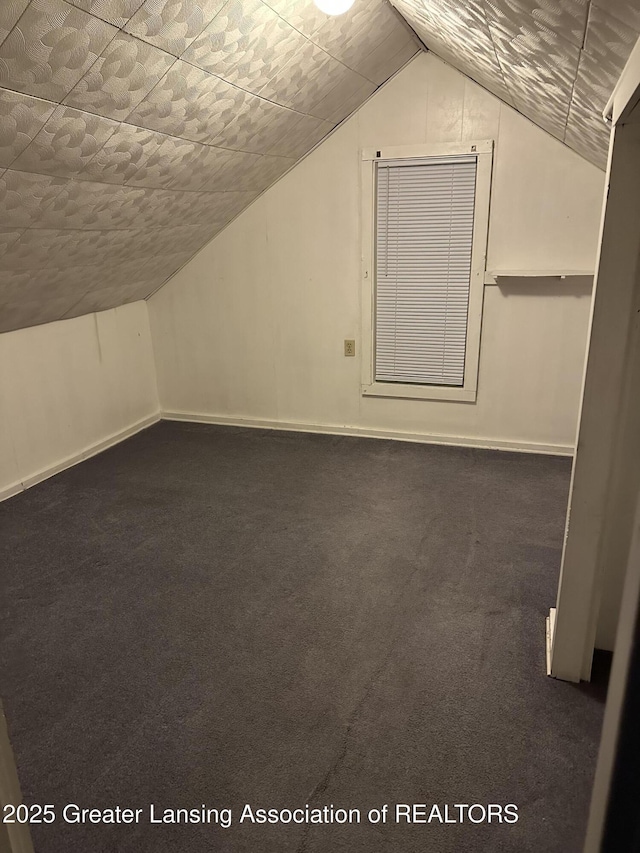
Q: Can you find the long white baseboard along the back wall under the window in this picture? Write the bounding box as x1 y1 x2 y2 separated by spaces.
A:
162 412 574 456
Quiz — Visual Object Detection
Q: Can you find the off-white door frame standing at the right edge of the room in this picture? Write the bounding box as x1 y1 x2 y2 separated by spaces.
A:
548 40 640 682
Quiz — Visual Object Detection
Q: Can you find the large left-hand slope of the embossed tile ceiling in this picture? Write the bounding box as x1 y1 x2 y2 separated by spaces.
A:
0 0 420 331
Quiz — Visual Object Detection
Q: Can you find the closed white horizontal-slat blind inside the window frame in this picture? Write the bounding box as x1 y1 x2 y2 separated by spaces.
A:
375 155 476 386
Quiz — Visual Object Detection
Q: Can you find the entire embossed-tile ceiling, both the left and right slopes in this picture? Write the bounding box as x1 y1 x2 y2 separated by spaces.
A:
5 0 640 329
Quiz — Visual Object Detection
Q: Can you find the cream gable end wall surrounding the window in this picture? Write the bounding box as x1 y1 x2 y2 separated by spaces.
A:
149 54 604 450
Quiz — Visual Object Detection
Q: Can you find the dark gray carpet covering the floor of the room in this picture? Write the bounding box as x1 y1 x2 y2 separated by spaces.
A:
0 423 603 853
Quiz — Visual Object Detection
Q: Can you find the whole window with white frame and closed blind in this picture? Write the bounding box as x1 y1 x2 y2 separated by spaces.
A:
362 142 493 401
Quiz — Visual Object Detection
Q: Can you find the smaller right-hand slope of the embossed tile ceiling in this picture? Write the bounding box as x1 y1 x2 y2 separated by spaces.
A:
391 0 640 168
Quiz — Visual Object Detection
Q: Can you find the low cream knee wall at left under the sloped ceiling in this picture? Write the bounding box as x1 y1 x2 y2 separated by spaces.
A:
0 302 159 499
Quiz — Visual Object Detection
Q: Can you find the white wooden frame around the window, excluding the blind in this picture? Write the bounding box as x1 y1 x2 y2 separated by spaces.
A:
362 140 493 402
